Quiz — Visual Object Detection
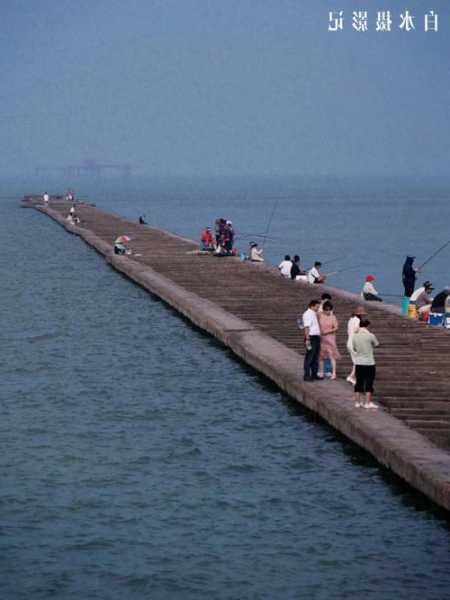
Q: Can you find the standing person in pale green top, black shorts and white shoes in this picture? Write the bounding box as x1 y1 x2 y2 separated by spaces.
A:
351 319 379 408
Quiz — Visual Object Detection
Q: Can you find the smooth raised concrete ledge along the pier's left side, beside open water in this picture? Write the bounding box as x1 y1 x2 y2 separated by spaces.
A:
34 207 450 510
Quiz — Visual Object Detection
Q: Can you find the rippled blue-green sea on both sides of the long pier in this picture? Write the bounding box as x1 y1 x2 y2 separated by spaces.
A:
0 180 450 600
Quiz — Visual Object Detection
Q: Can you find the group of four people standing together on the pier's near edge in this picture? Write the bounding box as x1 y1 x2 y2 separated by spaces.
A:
299 293 379 408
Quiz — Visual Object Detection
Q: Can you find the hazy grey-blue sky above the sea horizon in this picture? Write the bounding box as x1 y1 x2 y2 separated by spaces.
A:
0 0 450 175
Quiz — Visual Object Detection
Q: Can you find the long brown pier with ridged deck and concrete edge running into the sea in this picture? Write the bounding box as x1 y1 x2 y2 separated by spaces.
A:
22 196 450 510
